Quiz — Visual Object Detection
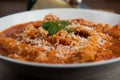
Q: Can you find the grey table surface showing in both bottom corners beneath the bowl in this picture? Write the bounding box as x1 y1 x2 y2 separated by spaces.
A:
0 64 120 80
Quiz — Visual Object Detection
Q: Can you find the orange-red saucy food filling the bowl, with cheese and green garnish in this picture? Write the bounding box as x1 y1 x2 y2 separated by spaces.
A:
0 14 120 64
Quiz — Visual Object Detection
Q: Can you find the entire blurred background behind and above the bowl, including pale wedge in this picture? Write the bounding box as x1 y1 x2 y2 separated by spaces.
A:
0 0 120 17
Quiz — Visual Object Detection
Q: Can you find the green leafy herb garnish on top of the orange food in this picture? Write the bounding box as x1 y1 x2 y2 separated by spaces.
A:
43 21 73 35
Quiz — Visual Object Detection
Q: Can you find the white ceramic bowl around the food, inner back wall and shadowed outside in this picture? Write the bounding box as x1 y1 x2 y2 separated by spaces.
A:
0 9 120 80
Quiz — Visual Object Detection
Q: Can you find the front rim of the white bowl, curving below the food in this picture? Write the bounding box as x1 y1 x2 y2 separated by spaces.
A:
0 55 120 68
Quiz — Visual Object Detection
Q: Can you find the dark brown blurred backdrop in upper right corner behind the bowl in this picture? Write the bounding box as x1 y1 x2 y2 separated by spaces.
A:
83 0 120 14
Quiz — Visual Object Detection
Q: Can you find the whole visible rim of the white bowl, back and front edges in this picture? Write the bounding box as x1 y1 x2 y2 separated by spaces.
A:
0 8 120 68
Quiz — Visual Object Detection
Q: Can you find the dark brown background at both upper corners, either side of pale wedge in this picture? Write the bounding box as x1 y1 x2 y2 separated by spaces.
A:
0 0 120 17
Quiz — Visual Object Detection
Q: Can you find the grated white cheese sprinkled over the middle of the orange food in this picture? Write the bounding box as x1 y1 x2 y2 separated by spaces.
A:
15 15 112 59
